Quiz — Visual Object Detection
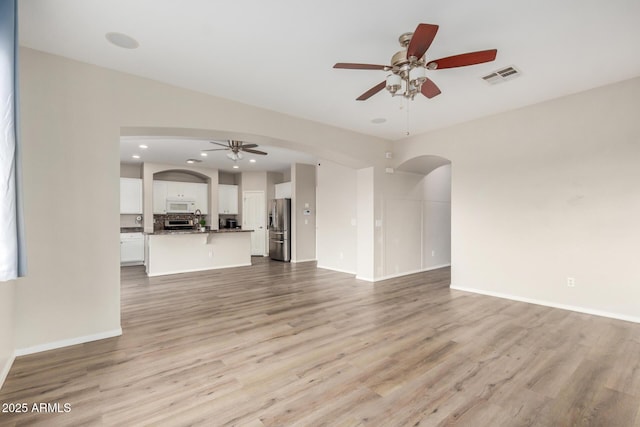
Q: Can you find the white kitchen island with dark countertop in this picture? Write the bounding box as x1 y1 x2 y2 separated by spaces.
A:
145 229 253 277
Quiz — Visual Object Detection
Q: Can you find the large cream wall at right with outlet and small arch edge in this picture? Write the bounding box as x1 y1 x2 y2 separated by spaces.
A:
395 78 640 321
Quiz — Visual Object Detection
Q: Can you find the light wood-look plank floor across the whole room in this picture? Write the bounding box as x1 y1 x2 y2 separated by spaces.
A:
0 258 640 427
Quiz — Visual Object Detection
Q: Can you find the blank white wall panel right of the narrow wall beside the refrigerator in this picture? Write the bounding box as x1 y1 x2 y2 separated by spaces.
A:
316 160 358 274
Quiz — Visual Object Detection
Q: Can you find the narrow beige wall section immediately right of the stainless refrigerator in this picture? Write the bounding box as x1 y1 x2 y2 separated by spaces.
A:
291 163 317 262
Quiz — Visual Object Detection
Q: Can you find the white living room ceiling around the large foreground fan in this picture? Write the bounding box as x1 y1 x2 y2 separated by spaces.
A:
18 0 640 161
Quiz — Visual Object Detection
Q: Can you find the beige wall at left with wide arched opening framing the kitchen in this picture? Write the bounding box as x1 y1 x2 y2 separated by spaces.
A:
13 48 390 354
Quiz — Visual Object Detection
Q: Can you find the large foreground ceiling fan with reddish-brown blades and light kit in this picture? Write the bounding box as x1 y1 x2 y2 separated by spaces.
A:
333 24 498 101
